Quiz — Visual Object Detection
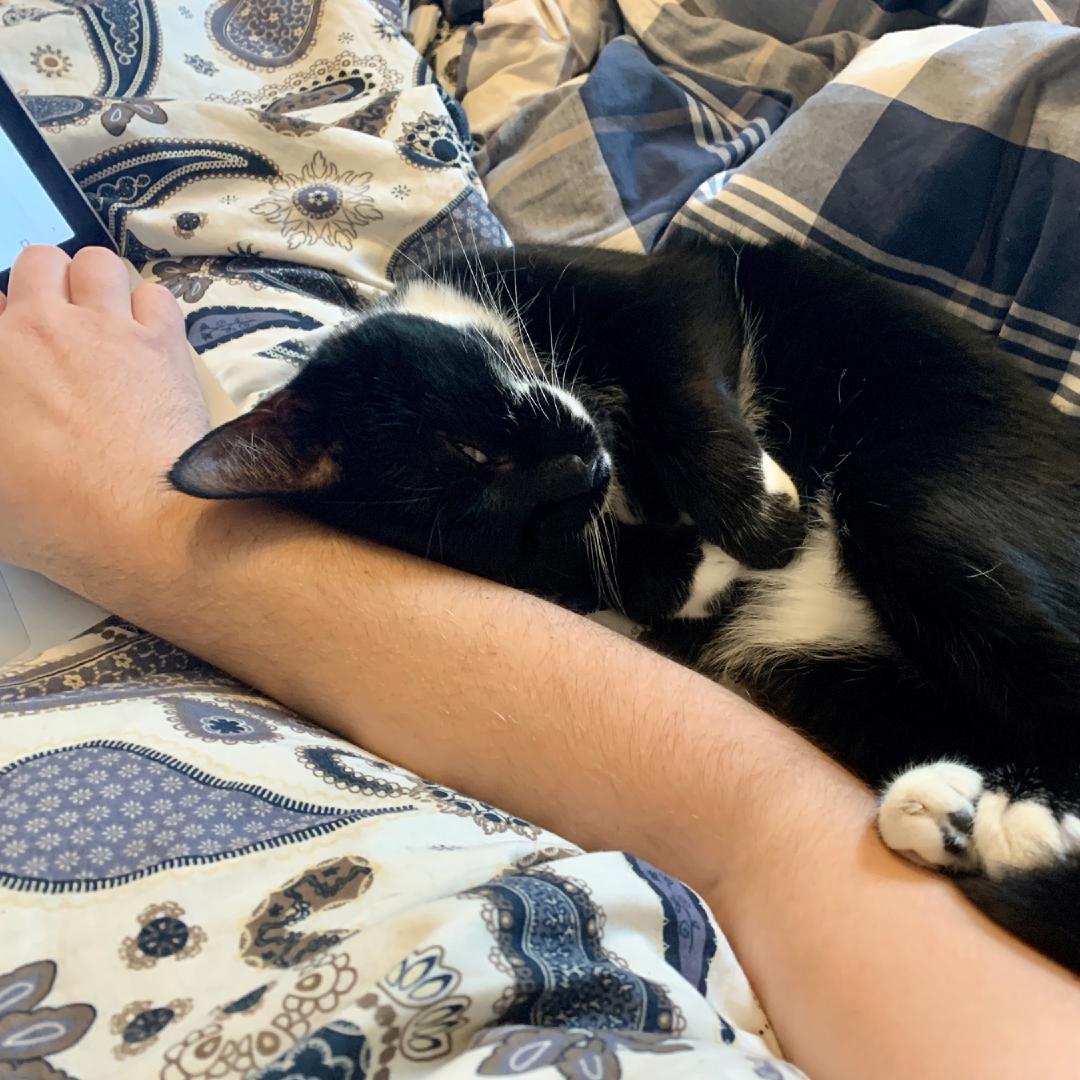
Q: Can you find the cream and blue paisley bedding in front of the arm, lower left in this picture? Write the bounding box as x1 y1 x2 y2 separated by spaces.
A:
0 621 798 1080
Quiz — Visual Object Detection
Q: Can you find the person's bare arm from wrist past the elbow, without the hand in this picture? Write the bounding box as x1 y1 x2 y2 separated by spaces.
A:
52 496 1080 1080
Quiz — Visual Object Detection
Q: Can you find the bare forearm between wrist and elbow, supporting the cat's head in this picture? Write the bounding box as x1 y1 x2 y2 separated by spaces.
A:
63 496 751 876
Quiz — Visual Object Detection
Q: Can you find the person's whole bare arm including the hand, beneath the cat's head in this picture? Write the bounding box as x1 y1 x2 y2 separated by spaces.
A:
6 252 1080 1080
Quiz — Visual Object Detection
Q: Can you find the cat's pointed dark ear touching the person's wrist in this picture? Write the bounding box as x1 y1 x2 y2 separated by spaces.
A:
168 387 338 499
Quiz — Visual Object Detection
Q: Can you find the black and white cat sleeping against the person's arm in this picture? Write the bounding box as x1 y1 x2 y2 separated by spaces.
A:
171 244 1080 972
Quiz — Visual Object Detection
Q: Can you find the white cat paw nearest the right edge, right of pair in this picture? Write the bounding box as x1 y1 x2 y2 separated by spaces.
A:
972 792 1075 878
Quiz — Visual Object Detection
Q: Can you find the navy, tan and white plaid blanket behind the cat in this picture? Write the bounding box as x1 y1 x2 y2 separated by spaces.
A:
416 0 1080 415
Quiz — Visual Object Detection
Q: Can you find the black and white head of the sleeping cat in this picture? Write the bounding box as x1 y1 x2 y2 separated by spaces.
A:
170 282 611 592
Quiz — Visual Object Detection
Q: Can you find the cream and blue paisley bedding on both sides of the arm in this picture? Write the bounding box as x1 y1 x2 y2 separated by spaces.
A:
0 0 797 1080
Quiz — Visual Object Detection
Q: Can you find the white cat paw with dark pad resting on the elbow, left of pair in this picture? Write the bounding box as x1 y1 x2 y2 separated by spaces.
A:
878 761 983 869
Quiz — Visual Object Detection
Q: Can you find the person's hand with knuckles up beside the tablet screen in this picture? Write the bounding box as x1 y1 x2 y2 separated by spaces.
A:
0 247 208 588
